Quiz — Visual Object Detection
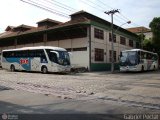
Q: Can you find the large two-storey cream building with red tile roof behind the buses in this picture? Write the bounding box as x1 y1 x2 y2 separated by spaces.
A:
0 11 139 71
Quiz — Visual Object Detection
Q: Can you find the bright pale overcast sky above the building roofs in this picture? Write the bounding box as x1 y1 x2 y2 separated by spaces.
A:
0 0 160 32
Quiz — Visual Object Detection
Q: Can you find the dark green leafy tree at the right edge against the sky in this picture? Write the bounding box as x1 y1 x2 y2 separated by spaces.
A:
149 17 160 47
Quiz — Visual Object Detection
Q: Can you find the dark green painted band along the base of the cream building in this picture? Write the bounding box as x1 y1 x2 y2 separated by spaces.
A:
91 63 119 71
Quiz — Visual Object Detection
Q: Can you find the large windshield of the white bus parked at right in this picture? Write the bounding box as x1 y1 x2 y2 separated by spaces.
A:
120 51 139 66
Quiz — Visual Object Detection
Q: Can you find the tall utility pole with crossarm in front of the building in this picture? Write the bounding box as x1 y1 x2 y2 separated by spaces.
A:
104 9 119 73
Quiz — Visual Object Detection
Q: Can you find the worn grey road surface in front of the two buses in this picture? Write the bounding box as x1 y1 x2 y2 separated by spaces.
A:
0 70 160 119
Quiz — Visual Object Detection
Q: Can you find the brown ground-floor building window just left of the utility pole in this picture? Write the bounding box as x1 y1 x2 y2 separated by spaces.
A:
95 48 104 61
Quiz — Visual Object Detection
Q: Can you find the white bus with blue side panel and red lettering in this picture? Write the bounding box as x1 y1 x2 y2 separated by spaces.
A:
2 46 71 73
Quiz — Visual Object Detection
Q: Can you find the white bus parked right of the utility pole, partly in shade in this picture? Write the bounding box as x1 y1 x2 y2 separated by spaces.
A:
120 49 158 71
